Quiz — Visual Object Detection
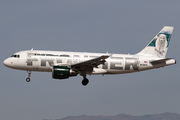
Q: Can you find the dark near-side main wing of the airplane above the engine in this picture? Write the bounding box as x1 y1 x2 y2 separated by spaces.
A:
71 55 110 71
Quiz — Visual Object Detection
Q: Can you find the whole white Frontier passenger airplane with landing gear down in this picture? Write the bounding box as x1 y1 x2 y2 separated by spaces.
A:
3 26 176 86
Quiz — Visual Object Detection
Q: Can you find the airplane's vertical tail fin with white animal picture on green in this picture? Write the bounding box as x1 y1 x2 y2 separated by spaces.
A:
138 26 174 58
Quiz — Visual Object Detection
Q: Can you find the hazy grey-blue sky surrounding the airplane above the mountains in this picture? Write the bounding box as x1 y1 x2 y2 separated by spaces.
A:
0 0 180 120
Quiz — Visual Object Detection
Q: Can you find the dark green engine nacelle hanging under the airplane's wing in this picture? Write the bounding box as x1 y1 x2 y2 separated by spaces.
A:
52 66 78 79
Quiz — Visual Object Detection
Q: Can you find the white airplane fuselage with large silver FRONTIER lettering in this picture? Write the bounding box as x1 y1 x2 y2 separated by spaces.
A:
4 50 176 74
